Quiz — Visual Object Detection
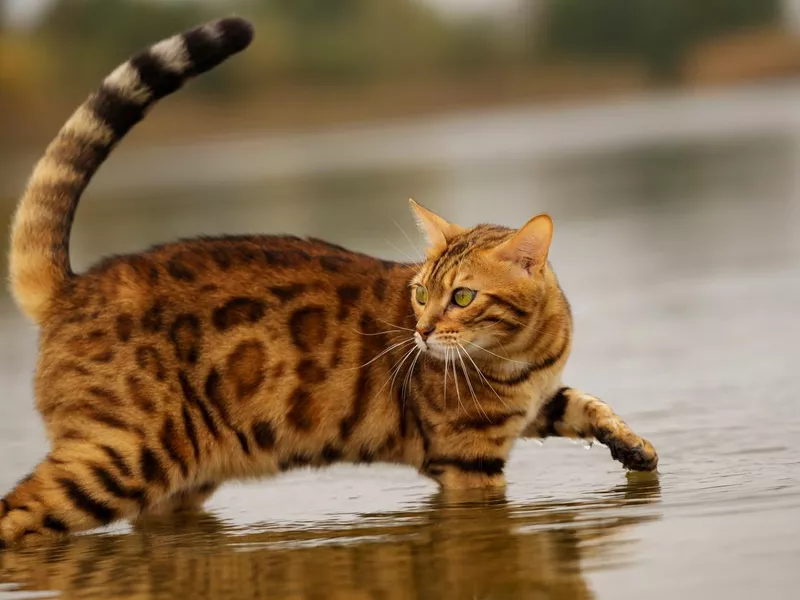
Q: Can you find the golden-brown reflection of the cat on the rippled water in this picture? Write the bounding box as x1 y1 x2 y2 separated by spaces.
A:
0 476 661 600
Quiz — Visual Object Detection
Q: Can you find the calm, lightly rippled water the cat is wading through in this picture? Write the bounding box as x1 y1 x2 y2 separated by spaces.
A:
0 89 800 600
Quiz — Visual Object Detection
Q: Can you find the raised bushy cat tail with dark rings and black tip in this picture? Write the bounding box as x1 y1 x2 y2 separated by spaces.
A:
10 17 253 323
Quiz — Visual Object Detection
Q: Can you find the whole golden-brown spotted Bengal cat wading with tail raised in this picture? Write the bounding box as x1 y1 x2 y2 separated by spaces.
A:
0 18 657 546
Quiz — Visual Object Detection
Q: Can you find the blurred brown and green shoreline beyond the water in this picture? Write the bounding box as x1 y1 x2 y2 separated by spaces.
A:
0 0 800 143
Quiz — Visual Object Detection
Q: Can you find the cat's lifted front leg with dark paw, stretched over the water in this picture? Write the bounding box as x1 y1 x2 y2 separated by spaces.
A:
521 387 658 471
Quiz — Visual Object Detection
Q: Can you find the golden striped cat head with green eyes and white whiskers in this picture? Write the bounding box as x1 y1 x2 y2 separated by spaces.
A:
410 200 554 358
